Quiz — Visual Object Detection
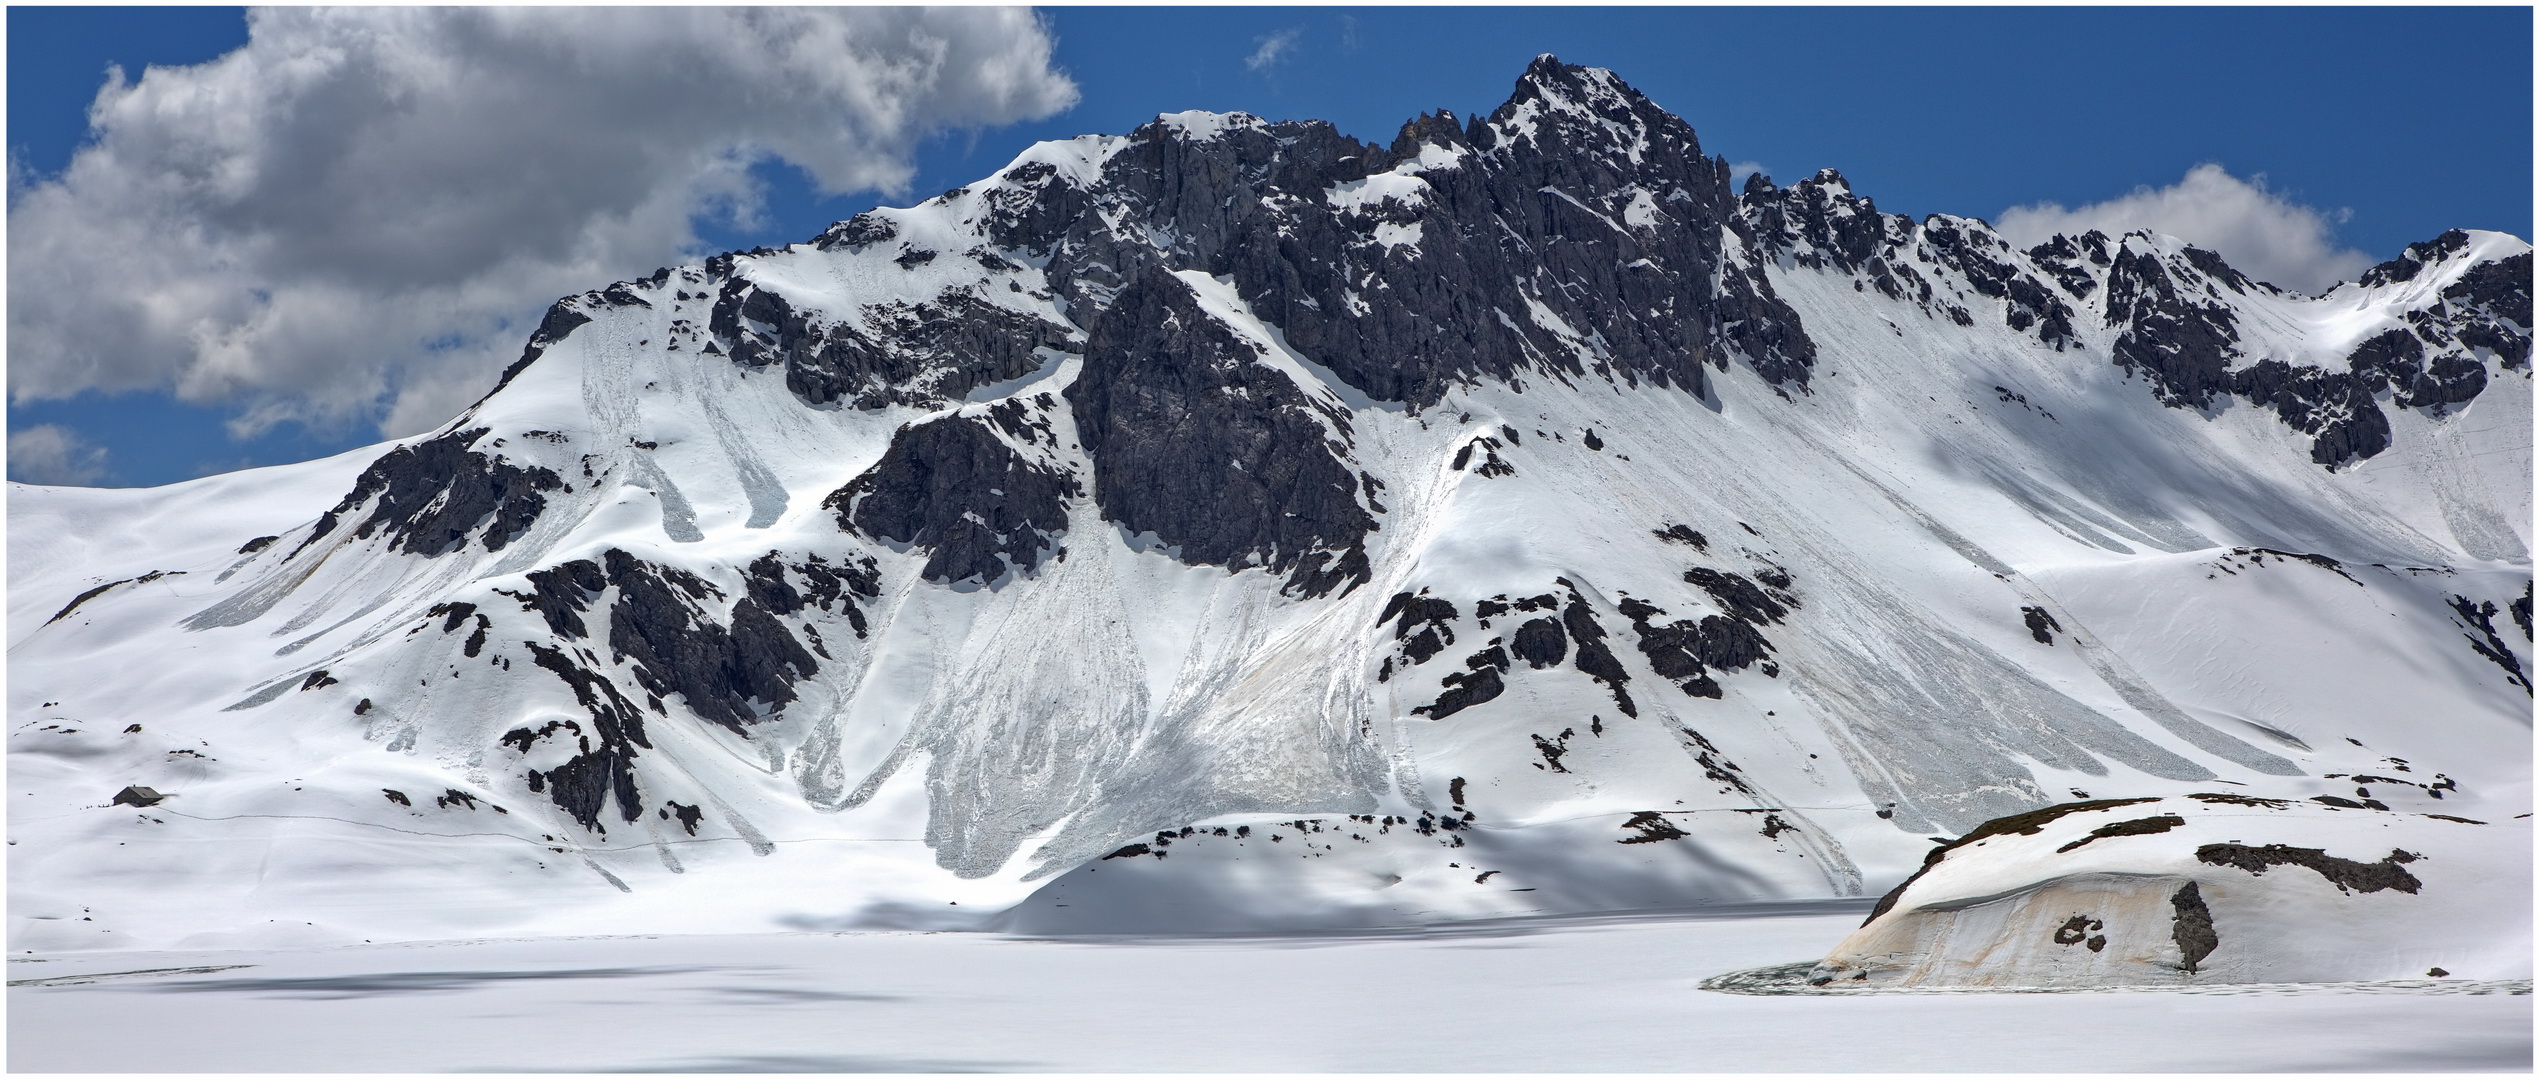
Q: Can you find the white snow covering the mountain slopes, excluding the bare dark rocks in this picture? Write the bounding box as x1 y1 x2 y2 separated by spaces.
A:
8 114 2531 970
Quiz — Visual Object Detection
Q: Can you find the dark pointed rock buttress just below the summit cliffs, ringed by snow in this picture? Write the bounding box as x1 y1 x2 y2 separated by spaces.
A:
1066 272 1376 597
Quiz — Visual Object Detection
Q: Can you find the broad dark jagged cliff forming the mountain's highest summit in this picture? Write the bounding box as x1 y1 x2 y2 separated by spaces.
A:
995 58 1815 407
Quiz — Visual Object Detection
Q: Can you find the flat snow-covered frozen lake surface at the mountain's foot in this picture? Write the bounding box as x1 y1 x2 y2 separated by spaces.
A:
8 902 2531 1072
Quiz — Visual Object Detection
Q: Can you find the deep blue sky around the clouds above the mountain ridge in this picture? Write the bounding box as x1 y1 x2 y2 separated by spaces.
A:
8 8 2531 485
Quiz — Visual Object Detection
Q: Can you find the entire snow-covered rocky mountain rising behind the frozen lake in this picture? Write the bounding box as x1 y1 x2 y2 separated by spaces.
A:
8 56 2531 953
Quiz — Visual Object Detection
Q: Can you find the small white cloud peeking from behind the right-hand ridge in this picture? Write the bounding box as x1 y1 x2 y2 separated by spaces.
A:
1996 163 2371 292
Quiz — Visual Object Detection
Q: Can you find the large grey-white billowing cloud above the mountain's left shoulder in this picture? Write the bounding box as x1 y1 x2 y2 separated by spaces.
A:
8 8 1077 437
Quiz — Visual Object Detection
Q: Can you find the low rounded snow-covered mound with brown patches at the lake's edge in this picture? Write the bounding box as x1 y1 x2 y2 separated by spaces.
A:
1808 793 2531 989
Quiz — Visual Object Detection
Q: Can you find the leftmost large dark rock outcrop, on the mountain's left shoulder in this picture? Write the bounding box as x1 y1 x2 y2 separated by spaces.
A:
309 427 564 557
